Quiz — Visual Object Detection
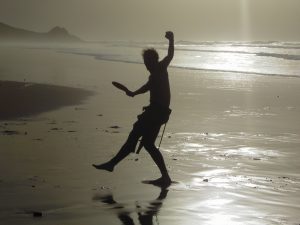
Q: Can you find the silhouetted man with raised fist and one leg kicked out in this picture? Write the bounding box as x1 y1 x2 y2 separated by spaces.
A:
93 31 174 186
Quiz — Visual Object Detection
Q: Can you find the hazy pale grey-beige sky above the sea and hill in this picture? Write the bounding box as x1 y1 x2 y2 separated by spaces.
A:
0 0 300 41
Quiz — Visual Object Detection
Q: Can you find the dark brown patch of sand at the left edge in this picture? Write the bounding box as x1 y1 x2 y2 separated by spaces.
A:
0 81 92 120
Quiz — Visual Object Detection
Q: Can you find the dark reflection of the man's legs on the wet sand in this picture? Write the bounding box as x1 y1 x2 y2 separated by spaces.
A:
93 188 168 225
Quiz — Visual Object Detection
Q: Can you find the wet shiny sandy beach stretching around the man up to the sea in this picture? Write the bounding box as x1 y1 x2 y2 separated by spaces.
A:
0 47 300 225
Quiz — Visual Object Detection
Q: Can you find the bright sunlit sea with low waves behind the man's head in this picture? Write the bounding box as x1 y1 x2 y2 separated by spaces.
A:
35 41 300 77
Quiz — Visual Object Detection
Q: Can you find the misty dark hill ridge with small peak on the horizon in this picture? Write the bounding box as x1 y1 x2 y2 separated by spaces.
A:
0 22 82 42
